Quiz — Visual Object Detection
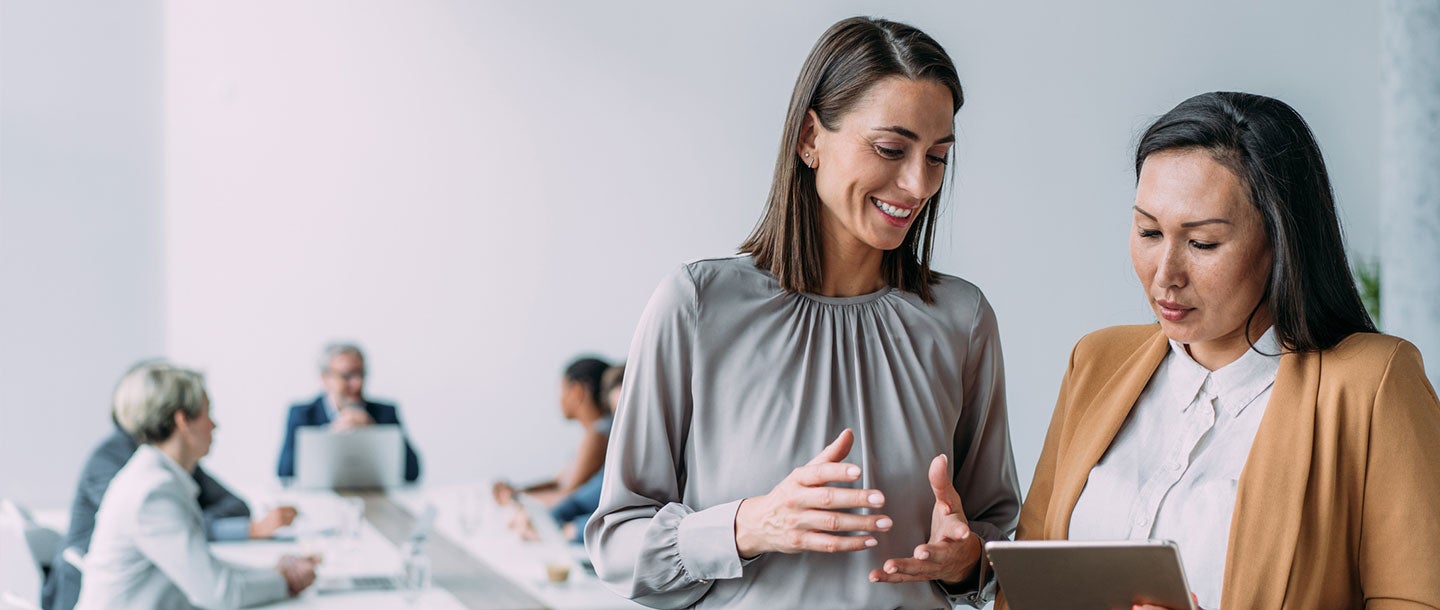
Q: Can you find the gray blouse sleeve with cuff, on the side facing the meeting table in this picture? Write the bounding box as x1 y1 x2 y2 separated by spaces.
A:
585 269 742 609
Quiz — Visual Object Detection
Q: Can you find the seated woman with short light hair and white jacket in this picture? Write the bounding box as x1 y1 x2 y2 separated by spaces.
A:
76 363 315 610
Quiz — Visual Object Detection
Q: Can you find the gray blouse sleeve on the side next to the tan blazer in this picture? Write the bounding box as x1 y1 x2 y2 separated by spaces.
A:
945 295 1020 606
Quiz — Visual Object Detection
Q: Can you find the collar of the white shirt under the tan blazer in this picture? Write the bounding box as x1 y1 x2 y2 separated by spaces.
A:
1166 327 1280 416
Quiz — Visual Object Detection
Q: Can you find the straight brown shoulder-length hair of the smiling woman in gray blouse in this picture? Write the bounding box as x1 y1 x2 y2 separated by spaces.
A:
740 17 965 302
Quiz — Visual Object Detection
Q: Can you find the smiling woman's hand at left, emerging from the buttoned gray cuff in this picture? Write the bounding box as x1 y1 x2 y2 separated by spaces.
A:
734 429 894 558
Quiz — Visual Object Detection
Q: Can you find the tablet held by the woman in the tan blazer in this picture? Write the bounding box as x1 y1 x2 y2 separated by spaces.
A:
985 540 1195 610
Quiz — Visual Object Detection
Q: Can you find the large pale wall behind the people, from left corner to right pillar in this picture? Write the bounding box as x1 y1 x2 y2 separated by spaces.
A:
2 0 1378 506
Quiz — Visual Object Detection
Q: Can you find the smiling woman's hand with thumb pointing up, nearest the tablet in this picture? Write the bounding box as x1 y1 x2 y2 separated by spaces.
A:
870 455 981 583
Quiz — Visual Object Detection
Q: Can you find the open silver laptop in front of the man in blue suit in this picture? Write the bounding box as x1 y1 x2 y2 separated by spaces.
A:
295 424 405 489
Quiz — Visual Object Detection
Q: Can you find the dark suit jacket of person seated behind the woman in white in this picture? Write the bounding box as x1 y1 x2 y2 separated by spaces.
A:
40 427 251 610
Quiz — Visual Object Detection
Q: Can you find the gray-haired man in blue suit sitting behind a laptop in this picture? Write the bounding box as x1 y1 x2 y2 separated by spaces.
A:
276 342 420 481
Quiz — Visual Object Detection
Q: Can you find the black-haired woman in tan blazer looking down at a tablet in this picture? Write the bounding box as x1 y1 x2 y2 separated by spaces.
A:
999 92 1440 610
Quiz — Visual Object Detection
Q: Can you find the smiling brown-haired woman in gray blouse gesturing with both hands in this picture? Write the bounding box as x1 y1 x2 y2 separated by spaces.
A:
585 17 1020 609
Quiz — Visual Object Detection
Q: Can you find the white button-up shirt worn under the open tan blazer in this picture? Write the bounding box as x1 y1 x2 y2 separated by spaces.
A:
1070 328 1280 609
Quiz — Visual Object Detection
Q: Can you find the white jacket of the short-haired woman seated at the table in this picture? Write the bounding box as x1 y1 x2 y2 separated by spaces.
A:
75 445 289 610
